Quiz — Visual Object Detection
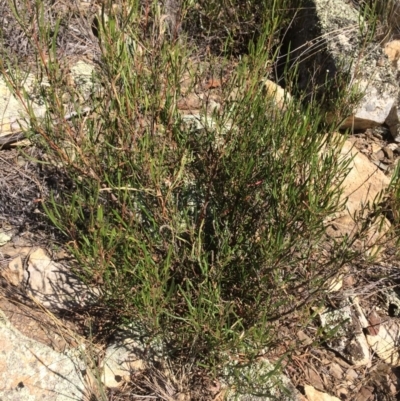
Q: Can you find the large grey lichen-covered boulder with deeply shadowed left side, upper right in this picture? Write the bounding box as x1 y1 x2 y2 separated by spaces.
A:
287 0 400 138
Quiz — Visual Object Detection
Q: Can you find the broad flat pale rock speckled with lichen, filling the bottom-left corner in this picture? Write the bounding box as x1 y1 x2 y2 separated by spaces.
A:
0 311 84 401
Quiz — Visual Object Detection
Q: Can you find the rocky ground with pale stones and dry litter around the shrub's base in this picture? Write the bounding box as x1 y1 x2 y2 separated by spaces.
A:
0 0 400 401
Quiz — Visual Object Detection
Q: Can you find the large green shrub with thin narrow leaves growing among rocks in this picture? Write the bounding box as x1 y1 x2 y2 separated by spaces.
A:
1 1 398 396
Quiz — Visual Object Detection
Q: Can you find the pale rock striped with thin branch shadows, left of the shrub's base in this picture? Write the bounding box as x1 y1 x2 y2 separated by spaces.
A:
26 248 96 309
